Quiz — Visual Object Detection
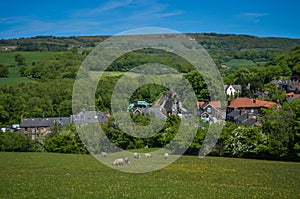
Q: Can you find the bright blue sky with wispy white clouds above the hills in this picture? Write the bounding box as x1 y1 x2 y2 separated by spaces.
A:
0 0 300 39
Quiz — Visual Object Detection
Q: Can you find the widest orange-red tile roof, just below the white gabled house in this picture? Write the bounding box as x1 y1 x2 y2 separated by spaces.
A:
227 98 276 108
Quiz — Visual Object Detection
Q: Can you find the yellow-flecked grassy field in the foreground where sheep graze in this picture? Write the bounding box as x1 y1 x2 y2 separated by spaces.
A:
0 152 300 199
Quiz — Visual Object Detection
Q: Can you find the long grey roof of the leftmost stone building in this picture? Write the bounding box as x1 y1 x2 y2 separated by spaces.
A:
20 117 70 128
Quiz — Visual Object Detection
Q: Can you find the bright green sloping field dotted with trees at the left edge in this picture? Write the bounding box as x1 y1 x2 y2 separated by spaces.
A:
0 51 62 85
